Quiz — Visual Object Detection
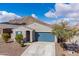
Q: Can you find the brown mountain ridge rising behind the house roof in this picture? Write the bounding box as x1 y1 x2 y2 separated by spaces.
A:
9 16 52 27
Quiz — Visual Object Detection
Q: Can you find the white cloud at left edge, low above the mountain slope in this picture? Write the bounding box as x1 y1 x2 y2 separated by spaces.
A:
0 11 22 22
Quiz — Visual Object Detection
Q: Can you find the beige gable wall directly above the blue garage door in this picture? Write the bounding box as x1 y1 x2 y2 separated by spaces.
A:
28 23 52 32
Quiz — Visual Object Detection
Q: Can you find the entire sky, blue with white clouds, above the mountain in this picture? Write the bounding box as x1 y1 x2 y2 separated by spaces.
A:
0 3 79 25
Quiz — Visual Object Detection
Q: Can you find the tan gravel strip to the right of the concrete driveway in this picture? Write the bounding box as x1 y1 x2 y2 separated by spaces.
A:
55 43 79 56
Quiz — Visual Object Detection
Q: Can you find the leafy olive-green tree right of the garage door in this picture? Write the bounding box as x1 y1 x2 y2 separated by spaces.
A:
52 22 78 43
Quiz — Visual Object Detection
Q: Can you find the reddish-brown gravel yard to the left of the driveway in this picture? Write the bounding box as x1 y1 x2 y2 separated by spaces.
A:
0 41 28 56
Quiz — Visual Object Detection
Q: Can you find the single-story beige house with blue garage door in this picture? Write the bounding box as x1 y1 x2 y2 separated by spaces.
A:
11 23 55 42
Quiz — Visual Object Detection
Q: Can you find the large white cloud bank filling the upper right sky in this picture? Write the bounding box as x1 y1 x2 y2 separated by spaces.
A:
44 3 79 23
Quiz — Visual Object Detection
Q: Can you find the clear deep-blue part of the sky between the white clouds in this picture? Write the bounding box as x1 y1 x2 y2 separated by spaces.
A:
0 3 55 22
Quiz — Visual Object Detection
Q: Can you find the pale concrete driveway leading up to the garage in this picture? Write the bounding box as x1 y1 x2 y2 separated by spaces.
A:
21 42 55 56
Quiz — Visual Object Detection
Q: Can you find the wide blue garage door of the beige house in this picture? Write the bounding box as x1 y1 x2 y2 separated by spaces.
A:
35 32 55 42
